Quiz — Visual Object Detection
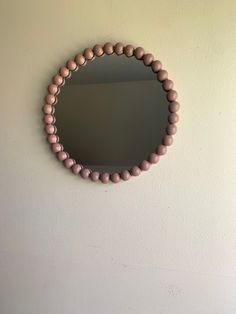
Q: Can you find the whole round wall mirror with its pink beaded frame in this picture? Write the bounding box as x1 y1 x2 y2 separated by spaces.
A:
44 43 179 183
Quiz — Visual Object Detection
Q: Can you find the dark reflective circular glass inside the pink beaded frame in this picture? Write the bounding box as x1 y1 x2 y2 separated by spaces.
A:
55 54 168 173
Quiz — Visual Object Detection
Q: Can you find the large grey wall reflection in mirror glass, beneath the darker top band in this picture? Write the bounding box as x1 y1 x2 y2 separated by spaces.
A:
56 80 168 168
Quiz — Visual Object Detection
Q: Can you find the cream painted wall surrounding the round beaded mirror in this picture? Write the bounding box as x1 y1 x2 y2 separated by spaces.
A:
0 0 236 314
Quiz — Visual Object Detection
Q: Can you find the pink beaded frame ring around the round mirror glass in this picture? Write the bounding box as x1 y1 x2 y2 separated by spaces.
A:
43 43 180 183
